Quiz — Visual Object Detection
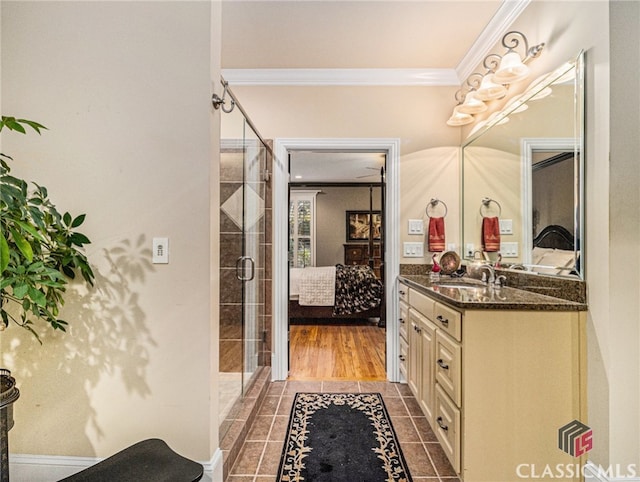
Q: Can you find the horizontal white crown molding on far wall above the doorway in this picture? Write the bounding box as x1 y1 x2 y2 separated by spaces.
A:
222 69 460 86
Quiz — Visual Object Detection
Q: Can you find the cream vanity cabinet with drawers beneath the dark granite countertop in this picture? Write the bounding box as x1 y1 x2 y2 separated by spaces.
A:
403 287 586 482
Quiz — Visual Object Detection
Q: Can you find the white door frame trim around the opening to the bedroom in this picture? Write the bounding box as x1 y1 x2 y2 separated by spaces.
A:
272 139 400 381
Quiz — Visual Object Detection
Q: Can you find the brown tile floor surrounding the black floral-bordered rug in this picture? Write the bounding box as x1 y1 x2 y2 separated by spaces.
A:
227 381 458 482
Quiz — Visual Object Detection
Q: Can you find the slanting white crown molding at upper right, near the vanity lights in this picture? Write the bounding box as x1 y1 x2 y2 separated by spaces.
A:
455 0 531 84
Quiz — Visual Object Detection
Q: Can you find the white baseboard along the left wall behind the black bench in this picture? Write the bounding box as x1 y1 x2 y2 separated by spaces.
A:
9 449 224 482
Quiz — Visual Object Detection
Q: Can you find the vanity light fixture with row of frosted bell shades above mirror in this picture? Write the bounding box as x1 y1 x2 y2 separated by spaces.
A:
447 30 545 127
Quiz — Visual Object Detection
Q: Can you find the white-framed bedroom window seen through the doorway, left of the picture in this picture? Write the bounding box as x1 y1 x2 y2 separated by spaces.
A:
289 191 317 268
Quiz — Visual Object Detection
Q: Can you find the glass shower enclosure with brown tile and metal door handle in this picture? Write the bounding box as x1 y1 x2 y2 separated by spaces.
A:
219 87 271 439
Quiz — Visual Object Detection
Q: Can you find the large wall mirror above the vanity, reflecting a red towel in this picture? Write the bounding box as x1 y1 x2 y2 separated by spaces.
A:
462 52 584 279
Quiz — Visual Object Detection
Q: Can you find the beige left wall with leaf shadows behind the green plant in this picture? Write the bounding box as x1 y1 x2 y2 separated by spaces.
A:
1 2 219 466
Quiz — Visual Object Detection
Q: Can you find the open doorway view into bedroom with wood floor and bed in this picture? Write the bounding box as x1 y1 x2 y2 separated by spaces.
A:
288 150 387 381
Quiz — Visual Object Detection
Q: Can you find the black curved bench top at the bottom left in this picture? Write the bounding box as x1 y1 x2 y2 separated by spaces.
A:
59 439 204 482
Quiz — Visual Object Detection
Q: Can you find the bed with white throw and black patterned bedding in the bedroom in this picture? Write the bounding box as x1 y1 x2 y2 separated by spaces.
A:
289 264 384 319
